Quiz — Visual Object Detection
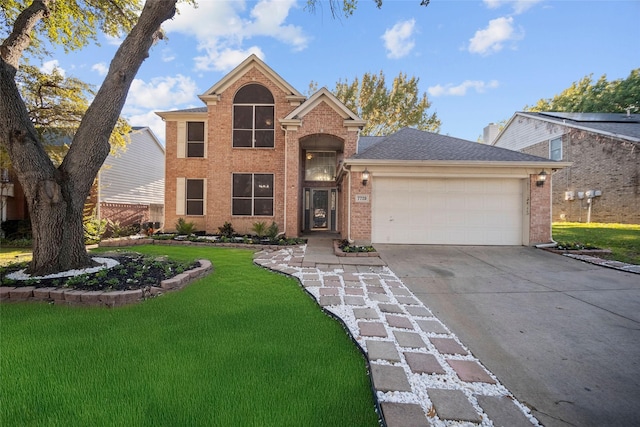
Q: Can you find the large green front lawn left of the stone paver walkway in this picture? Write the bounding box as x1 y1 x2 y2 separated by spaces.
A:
0 246 378 427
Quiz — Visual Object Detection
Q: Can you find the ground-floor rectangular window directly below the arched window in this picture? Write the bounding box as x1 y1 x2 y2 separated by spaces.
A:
231 173 273 216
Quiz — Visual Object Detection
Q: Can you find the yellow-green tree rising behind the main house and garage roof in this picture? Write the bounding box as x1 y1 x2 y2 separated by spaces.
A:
336 71 440 136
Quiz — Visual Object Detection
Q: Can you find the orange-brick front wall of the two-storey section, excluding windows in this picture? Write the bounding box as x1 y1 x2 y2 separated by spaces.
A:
163 56 358 237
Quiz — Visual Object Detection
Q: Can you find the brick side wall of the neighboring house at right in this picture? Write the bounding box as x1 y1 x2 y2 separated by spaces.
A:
522 129 640 224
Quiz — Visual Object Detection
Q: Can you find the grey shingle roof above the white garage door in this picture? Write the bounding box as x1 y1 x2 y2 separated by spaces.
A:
353 128 550 162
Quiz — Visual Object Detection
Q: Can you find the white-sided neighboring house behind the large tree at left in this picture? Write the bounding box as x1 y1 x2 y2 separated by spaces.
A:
0 127 164 232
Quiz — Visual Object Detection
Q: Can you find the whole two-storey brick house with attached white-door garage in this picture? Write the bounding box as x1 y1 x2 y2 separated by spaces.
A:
157 55 566 245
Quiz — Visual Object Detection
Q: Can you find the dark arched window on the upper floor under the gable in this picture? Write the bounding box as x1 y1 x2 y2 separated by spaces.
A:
233 83 275 148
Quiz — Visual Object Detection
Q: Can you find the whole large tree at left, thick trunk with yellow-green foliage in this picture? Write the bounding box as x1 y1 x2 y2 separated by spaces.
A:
0 0 176 275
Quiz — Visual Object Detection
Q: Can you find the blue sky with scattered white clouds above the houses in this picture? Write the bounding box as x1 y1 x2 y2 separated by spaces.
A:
37 0 640 141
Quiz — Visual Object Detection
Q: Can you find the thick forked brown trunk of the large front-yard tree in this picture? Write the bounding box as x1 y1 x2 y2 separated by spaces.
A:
0 0 176 275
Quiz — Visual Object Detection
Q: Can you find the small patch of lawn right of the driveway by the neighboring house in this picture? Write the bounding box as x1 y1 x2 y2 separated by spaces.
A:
553 222 640 264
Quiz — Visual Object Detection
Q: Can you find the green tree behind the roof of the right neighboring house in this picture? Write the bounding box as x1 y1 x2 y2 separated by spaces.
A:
524 68 640 113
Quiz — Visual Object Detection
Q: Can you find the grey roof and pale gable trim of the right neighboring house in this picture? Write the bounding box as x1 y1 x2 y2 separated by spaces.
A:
493 111 640 144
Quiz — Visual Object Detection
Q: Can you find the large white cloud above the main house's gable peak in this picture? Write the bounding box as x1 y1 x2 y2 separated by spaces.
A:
165 0 309 72
